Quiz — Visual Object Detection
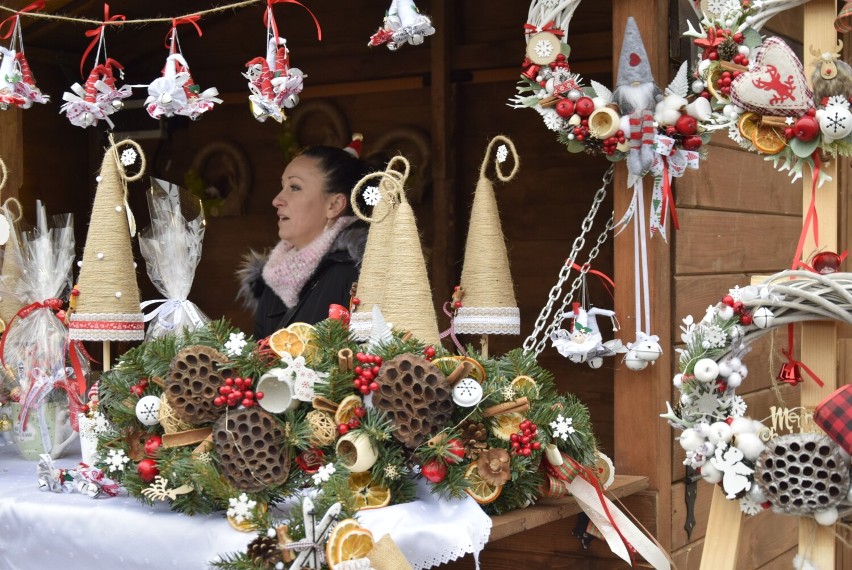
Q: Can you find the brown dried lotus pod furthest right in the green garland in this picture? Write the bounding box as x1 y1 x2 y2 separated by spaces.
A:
373 354 453 449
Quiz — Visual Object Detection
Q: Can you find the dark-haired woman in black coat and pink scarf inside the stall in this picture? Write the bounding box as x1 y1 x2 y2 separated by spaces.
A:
238 139 372 339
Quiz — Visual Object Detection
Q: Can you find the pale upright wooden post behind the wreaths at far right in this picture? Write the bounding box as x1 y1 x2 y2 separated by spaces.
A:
799 0 838 568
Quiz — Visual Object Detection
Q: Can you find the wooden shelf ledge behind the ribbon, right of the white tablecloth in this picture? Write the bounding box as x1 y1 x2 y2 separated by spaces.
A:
486 475 648 548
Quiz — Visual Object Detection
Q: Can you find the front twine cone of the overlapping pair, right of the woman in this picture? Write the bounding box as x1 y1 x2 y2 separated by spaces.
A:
381 153 441 345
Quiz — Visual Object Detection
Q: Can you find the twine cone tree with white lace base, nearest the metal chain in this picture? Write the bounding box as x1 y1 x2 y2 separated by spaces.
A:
453 136 521 334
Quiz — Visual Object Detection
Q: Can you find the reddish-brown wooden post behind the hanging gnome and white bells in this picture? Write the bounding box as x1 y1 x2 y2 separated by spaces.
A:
611 0 676 550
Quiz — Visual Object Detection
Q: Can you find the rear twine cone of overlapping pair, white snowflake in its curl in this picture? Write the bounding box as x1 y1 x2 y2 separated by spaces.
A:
349 156 409 341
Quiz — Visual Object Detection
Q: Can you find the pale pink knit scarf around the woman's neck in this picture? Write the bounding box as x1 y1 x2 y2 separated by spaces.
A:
263 216 356 309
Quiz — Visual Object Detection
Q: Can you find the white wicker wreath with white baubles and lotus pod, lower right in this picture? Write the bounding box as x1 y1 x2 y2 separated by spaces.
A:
662 271 852 524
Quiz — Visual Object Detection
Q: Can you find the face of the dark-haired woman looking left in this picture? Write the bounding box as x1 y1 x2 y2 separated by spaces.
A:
272 156 345 249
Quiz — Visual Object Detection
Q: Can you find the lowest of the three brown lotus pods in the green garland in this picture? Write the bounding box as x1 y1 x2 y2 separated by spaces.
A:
213 408 290 492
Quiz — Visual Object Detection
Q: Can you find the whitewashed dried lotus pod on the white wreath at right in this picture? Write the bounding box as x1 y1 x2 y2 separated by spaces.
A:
754 433 849 515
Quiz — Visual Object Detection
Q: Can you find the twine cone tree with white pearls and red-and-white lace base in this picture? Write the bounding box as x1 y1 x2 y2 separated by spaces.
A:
68 135 145 341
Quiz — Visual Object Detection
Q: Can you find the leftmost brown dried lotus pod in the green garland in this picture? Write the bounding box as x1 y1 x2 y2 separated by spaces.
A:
164 345 234 425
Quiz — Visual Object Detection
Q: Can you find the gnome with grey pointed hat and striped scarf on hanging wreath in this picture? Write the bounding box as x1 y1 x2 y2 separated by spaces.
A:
613 16 662 182
